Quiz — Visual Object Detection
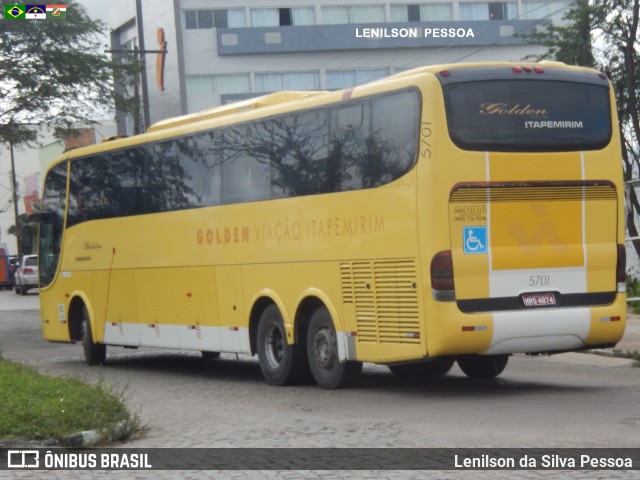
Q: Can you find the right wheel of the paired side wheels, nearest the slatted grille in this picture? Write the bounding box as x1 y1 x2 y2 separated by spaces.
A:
307 307 362 390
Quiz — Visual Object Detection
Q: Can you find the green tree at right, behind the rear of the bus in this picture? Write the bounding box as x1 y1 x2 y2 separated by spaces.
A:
532 0 640 255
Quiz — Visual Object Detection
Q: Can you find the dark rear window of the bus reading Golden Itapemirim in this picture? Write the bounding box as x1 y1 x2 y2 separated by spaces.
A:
444 80 611 152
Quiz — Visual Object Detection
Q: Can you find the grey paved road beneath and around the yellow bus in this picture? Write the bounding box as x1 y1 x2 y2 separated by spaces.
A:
0 291 640 478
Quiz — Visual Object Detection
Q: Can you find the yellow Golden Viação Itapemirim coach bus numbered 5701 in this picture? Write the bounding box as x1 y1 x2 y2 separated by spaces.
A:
39 63 626 388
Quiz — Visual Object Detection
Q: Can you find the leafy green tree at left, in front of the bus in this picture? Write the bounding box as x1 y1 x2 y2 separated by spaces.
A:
0 2 139 252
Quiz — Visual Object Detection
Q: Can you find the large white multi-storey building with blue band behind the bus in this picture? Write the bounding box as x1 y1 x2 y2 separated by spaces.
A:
109 0 571 134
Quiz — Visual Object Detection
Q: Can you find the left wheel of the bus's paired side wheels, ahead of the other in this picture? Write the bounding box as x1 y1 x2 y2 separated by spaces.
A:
256 305 306 386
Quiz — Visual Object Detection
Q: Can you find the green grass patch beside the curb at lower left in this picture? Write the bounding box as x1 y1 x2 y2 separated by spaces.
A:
0 358 139 441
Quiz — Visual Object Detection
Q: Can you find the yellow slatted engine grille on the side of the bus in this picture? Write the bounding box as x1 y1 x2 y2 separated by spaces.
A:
340 259 420 344
